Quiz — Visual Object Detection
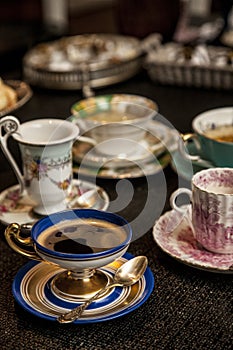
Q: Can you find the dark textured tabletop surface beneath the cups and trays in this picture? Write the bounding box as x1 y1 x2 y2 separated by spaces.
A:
0 71 233 350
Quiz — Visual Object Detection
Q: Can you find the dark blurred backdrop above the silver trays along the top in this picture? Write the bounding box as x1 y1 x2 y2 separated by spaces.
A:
0 0 233 71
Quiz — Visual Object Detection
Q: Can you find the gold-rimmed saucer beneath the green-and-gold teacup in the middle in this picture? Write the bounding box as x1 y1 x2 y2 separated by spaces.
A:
73 121 177 179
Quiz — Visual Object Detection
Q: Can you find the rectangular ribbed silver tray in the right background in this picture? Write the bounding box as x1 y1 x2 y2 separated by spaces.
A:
144 43 233 90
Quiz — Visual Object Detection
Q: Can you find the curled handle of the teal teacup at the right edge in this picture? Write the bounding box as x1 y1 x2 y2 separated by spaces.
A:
178 133 213 167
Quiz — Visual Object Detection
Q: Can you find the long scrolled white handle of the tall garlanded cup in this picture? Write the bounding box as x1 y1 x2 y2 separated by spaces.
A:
0 115 25 194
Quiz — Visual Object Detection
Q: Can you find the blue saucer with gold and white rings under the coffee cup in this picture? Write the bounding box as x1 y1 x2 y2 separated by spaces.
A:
12 253 154 324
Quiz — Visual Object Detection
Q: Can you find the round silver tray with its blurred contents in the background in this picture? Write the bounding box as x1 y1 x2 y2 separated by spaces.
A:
23 34 143 96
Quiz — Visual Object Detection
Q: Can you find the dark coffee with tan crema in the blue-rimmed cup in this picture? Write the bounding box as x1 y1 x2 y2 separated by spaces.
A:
38 218 127 254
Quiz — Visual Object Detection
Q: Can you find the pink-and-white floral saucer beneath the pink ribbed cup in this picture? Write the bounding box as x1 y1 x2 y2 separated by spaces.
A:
153 206 233 273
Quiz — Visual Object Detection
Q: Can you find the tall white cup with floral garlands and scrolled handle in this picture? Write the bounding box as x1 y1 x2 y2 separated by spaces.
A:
0 116 92 215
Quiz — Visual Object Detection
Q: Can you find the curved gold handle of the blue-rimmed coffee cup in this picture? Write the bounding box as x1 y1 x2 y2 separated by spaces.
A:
5 223 42 261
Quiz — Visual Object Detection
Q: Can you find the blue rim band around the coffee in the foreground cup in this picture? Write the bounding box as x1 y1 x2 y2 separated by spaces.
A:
31 209 132 260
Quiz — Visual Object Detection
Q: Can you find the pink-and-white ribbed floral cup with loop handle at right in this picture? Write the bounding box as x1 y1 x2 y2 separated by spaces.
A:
170 168 233 254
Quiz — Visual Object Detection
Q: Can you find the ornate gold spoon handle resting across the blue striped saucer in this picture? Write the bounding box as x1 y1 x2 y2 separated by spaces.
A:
57 282 118 323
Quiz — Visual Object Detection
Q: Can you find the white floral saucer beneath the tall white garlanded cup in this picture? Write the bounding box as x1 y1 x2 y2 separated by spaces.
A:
0 179 109 225
